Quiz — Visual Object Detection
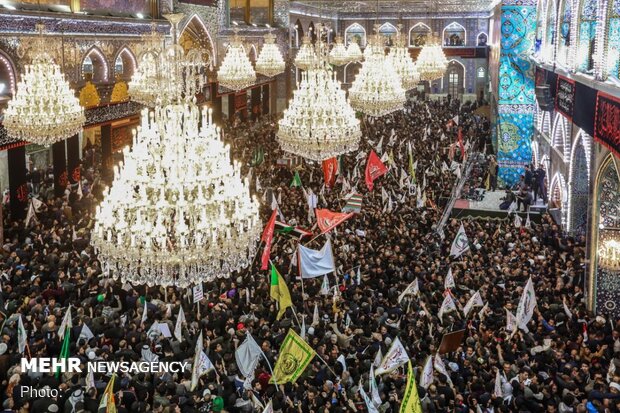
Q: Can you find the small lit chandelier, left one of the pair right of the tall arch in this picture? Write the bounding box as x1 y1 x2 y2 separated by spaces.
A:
217 28 256 91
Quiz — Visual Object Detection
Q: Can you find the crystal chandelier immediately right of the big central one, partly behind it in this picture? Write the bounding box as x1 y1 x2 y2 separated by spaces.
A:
349 26 406 117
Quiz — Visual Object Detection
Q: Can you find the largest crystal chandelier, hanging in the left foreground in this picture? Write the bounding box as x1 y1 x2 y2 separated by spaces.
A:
92 103 261 288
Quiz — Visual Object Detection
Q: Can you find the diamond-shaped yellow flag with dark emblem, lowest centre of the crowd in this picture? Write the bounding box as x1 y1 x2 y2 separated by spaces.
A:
272 330 316 384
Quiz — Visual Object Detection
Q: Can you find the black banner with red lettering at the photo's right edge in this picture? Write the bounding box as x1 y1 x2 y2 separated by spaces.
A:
594 92 620 156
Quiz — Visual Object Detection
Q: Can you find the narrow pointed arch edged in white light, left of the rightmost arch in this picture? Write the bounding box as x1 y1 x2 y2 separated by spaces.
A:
566 131 592 235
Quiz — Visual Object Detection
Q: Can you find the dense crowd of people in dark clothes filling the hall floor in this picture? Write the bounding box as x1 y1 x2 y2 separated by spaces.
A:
0 100 620 413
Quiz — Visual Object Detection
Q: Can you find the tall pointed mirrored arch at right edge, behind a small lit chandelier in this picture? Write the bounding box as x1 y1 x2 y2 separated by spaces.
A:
588 154 620 317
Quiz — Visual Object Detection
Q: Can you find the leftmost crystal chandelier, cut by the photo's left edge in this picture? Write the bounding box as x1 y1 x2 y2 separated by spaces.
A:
3 24 85 145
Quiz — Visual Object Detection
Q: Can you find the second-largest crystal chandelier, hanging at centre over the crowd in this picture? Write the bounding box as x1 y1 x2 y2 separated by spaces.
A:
276 25 362 161
